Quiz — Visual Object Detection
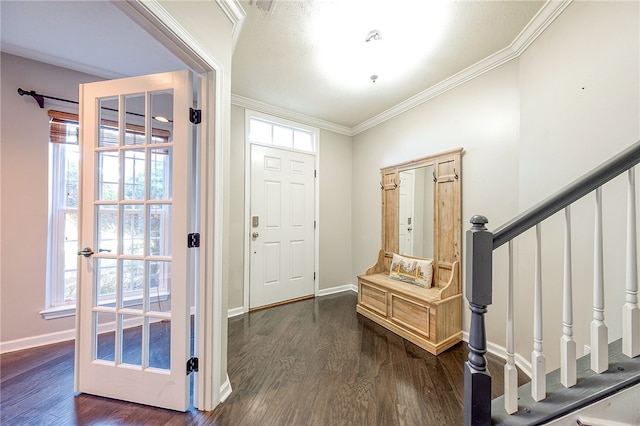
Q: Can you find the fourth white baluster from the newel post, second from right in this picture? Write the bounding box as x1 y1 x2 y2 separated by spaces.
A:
591 188 609 373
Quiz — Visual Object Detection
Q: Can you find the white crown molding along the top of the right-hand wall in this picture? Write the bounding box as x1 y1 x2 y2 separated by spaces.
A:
352 0 573 135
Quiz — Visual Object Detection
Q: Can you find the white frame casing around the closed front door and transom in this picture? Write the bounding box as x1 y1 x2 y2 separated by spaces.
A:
242 109 321 313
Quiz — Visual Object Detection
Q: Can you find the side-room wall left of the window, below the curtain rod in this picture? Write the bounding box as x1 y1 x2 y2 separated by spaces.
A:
0 53 102 343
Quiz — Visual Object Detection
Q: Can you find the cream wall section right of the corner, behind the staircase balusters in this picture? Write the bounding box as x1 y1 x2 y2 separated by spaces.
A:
516 2 640 366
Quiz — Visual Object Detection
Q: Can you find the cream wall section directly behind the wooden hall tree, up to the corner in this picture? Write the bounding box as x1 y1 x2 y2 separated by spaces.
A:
352 56 519 344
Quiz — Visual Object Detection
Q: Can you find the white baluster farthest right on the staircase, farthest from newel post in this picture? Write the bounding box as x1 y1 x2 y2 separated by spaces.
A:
622 168 640 358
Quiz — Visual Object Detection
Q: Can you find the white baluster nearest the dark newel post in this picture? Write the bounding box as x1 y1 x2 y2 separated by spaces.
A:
504 241 518 414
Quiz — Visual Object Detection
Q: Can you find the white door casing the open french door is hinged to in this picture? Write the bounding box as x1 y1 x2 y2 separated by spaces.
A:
92 0 245 411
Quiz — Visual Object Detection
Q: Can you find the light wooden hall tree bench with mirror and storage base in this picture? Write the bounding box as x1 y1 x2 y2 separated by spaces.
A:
356 148 462 355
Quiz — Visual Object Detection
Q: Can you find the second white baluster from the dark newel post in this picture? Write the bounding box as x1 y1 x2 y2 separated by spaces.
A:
531 224 547 401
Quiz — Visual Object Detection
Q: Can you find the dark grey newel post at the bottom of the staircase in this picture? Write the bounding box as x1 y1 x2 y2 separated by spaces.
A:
464 216 493 426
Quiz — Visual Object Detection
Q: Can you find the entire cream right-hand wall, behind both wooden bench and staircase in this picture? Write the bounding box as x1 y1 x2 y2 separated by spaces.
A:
352 2 640 369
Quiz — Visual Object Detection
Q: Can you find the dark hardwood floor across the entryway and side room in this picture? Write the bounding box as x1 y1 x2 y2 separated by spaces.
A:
0 292 528 425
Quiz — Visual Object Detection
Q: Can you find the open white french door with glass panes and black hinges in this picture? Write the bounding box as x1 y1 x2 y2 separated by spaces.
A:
75 71 193 411
